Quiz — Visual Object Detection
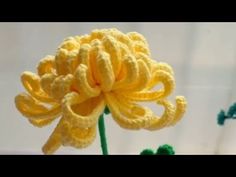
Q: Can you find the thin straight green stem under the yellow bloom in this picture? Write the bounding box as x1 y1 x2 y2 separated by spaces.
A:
98 114 108 155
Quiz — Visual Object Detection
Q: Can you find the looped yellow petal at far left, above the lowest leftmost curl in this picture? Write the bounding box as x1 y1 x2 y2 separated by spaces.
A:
21 71 54 102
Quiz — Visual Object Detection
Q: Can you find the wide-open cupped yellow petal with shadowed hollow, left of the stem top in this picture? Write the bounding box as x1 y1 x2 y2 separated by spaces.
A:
63 92 105 128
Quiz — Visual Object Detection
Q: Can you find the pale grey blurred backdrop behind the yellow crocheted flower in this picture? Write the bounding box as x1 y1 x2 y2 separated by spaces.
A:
0 23 236 154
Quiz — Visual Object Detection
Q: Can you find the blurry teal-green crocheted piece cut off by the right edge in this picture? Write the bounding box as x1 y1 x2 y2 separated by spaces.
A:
217 103 236 125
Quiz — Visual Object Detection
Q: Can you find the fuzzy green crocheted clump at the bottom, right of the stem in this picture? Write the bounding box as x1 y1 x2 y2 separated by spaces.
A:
140 144 175 155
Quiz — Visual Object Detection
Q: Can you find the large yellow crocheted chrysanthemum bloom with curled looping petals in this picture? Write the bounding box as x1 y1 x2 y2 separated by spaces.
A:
15 29 186 154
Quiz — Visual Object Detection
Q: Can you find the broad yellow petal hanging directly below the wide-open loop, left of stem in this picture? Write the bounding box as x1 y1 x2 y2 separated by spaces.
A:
62 123 96 148
